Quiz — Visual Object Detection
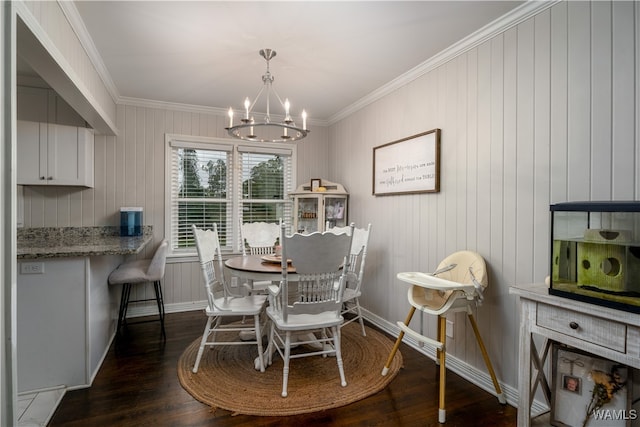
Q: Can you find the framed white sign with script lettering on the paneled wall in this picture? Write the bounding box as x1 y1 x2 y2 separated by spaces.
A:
373 129 440 196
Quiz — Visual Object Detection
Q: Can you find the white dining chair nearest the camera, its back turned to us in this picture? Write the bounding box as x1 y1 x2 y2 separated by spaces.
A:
267 225 353 397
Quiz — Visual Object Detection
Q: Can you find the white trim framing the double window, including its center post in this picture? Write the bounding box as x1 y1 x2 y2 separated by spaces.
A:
164 133 297 260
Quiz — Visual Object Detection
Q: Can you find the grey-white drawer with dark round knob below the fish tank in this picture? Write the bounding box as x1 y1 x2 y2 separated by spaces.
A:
536 304 627 353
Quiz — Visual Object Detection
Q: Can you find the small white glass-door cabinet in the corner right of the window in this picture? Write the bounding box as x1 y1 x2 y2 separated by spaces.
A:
291 180 349 233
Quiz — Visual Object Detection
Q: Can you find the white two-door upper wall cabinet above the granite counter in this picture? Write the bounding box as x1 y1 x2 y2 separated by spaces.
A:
17 120 94 187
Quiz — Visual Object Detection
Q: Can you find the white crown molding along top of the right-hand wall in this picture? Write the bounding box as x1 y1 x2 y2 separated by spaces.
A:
328 0 563 125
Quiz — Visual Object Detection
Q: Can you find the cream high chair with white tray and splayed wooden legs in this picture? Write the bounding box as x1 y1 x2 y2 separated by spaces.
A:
382 251 506 423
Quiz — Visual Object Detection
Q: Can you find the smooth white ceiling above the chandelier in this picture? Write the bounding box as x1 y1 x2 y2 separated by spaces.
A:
61 1 524 121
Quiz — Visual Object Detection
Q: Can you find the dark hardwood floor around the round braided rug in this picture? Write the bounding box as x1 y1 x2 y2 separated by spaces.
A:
49 311 516 427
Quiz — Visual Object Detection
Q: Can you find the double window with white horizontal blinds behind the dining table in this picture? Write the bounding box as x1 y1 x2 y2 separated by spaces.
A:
166 135 295 255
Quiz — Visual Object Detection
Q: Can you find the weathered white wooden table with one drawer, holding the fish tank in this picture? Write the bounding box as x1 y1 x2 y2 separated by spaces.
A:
509 283 640 427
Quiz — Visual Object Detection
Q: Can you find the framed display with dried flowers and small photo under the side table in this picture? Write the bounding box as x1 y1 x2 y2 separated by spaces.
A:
549 343 634 427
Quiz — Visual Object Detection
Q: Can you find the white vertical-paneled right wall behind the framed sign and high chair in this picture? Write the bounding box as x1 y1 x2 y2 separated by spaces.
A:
329 2 640 387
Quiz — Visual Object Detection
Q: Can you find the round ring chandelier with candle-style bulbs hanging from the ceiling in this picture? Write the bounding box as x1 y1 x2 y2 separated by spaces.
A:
225 49 310 142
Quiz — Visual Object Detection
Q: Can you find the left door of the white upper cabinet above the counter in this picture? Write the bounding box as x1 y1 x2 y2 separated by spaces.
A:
17 120 48 185
